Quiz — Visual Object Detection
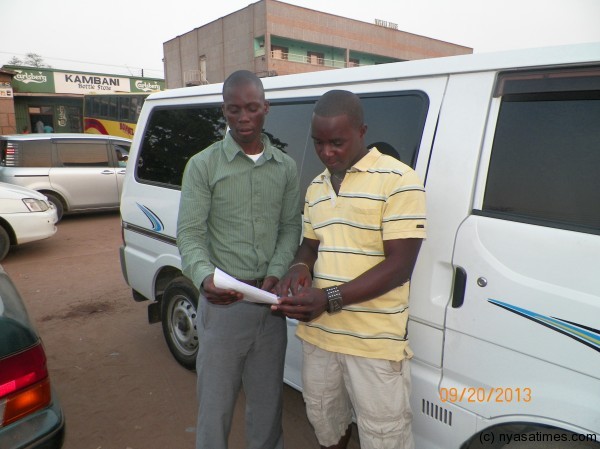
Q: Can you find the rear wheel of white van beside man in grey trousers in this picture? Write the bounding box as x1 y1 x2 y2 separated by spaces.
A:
161 277 198 370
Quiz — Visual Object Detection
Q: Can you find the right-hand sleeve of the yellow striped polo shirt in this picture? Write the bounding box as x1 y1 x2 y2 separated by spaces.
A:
382 169 426 240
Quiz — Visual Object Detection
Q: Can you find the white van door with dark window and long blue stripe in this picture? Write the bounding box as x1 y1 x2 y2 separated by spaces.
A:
441 67 600 432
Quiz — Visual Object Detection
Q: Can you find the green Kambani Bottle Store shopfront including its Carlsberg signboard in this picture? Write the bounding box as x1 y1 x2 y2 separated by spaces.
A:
0 65 164 134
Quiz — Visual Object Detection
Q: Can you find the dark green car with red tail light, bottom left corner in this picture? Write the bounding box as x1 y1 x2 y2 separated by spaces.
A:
0 267 65 449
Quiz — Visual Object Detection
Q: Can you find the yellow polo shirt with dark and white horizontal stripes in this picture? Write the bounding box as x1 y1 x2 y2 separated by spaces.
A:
297 148 426 361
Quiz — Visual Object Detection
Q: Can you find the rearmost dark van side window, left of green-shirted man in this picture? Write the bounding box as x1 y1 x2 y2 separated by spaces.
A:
135 105 226 189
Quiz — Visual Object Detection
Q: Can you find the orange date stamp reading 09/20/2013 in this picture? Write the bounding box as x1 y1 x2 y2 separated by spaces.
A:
439 387 533 403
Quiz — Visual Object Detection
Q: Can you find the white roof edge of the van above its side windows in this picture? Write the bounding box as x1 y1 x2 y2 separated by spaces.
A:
146 42 600 101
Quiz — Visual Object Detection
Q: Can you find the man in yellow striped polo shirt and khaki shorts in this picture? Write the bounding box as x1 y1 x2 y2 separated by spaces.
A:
273 90 425 449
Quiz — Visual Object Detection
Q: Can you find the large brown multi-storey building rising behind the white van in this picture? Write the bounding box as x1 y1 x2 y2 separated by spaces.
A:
163 0 473 89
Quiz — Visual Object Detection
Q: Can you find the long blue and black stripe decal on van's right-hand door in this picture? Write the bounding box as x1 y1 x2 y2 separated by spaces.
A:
488 299 600 352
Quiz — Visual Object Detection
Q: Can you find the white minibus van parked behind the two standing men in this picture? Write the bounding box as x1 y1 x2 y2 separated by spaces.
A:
121 43 600 449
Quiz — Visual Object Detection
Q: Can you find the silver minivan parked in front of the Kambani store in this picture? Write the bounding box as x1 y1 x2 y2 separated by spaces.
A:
0 133 131 220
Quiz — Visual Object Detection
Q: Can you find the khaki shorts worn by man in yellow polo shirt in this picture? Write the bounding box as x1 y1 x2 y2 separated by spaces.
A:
302 342 414 449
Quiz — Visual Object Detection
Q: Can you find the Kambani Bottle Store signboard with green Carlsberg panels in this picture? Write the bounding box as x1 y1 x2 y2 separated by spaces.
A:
4 66 165 94
